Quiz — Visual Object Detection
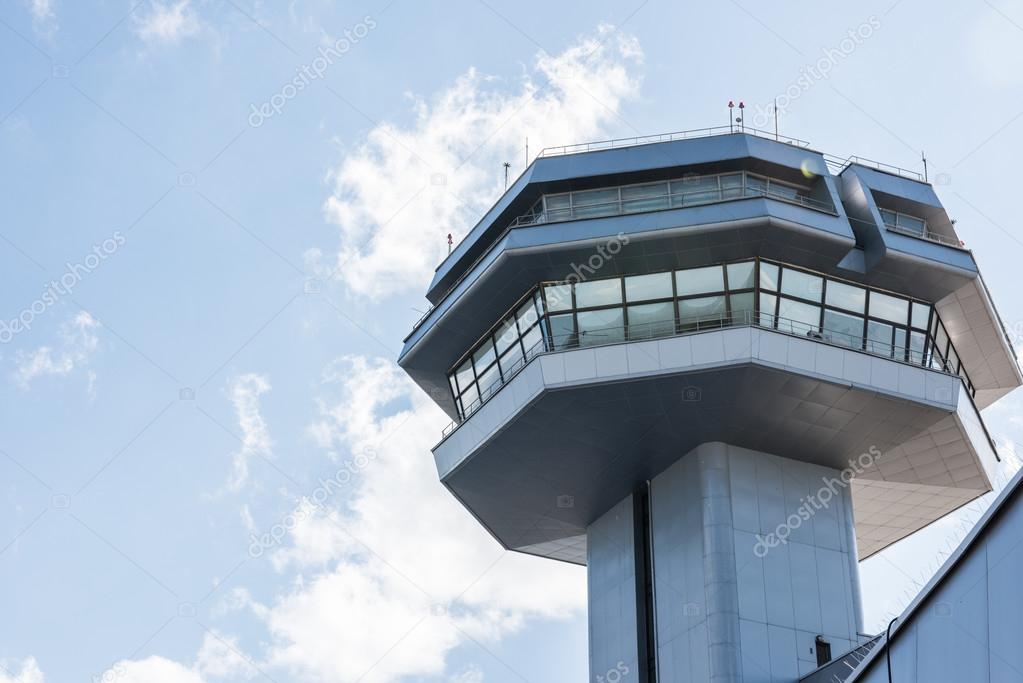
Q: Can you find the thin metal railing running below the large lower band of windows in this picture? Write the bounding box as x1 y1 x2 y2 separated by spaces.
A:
441 311 968 441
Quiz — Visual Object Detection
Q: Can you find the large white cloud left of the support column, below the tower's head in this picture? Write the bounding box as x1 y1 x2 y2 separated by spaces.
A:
251 357 585 683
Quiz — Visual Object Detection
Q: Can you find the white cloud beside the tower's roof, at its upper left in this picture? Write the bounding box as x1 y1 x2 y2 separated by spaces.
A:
324 27 641 300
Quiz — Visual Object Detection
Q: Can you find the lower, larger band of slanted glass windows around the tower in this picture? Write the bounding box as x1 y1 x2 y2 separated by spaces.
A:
448 254 973 416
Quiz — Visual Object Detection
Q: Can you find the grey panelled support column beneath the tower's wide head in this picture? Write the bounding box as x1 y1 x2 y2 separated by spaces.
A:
587 442 861 683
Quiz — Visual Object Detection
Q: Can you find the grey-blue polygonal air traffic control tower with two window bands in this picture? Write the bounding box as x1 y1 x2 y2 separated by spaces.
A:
399 129 1023 683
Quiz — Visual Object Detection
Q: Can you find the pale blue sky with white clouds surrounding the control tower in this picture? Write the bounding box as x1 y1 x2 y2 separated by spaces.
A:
6 0 1023 683
